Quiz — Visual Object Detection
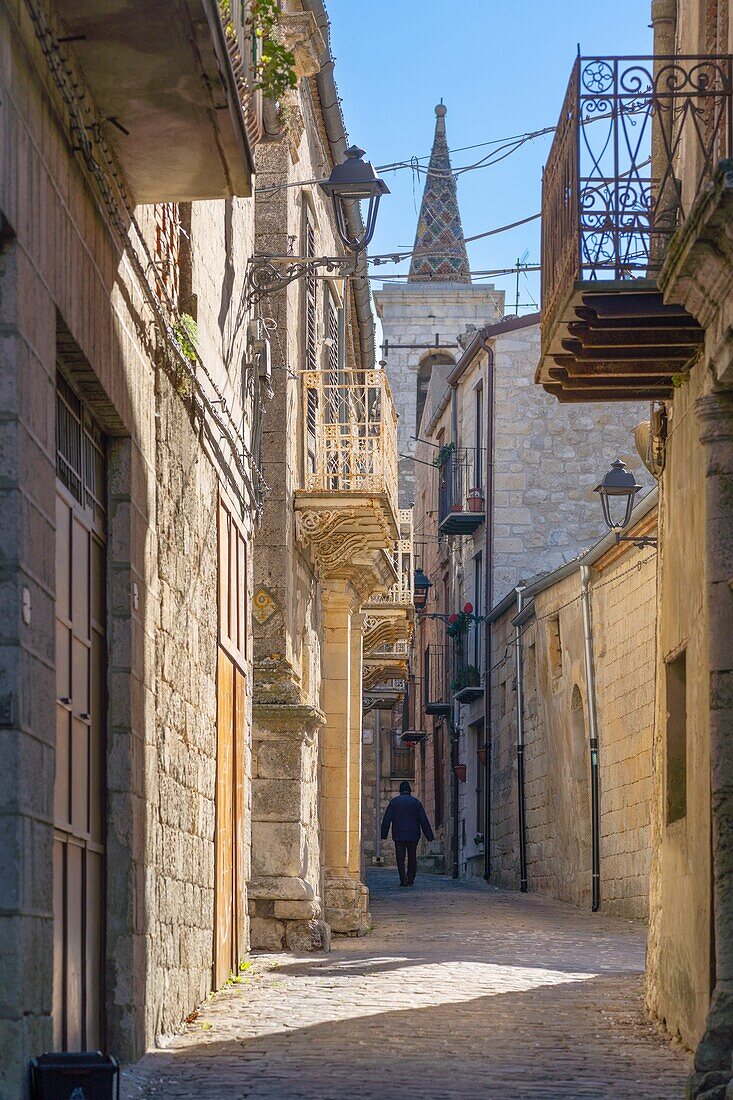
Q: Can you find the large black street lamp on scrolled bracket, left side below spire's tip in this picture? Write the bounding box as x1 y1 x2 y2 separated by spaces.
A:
247 145 390 305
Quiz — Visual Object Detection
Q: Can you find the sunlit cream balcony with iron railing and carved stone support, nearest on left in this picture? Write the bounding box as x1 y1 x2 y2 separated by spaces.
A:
296 371 404 598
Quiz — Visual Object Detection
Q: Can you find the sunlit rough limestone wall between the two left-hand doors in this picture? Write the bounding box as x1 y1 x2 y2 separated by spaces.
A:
147 378 218 1034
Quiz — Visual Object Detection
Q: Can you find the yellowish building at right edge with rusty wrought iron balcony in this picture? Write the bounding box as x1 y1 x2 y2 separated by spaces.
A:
530 0 733 1082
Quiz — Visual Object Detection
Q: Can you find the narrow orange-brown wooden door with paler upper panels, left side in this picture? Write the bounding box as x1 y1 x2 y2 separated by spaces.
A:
214 501 249 987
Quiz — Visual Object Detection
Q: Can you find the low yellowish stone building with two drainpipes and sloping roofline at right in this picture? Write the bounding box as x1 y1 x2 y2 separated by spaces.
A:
484 491 657 921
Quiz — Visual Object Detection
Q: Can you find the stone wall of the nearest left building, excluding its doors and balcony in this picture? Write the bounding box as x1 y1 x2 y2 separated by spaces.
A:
0 7 252 1100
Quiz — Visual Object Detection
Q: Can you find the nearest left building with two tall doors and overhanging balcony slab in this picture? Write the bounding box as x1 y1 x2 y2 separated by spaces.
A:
0 0 262 1086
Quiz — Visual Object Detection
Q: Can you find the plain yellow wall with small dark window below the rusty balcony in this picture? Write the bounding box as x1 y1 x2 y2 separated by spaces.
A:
646 364 708 1047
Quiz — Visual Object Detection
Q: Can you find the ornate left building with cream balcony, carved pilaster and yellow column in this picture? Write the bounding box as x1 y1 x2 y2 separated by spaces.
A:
249 0 400 950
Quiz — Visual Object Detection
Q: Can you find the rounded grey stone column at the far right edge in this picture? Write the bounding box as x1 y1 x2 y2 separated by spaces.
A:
688 392 733 1098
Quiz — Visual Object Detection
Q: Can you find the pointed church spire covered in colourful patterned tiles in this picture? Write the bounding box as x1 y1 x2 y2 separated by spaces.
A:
407 103 471 283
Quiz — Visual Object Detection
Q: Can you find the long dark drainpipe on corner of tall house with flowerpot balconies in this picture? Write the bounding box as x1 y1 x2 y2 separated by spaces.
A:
483 341 494 882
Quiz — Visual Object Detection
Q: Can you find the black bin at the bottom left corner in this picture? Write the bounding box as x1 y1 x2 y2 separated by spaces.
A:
31 1051 120 1100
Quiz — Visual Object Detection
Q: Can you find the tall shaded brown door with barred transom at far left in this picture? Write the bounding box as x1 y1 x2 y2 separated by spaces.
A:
53 377 106 1051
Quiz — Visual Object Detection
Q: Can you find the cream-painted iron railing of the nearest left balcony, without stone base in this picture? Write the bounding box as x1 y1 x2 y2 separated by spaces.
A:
303 371 398 517
